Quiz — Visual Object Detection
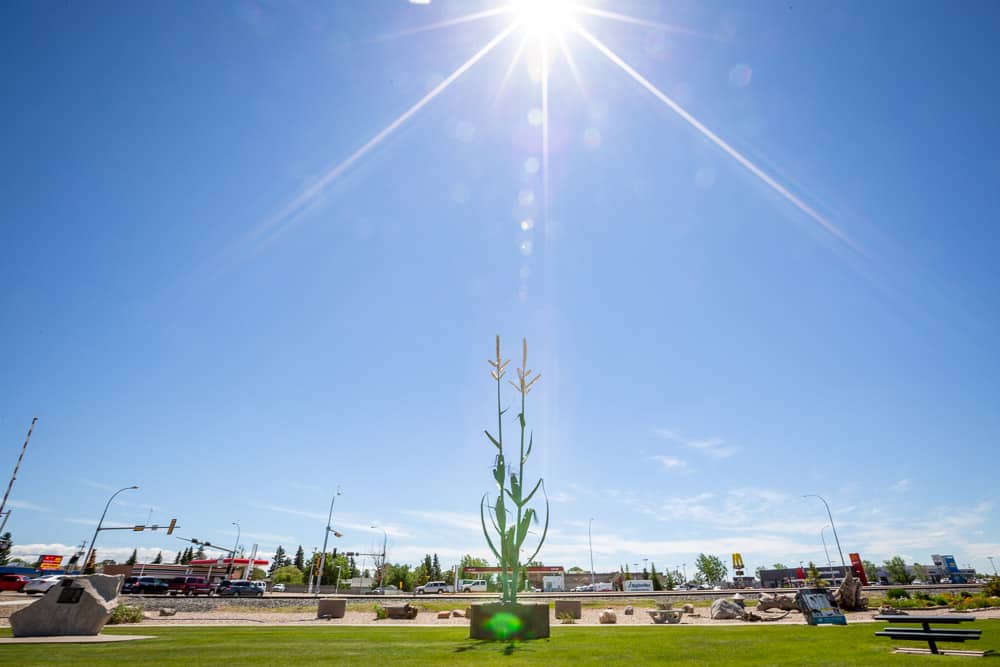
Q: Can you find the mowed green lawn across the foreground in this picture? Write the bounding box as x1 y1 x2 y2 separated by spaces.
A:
0 621 1000 667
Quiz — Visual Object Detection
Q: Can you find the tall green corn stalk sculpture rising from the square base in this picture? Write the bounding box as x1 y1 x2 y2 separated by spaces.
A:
479 336 549 604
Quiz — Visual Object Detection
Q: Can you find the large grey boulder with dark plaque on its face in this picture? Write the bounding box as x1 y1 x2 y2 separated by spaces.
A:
10 574 123 637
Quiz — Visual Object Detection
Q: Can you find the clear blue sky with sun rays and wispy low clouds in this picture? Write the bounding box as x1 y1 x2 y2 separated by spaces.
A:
0 0 1000 570
